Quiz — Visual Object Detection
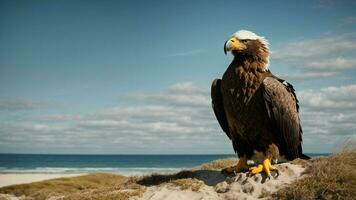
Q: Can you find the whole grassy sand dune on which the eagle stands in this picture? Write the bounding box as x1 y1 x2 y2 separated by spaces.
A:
0 152 356 200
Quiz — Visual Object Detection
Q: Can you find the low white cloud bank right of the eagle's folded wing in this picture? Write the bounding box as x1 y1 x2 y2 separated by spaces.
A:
297 85 356 151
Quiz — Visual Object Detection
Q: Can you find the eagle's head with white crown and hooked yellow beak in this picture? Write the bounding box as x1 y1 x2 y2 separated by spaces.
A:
224 30 269 70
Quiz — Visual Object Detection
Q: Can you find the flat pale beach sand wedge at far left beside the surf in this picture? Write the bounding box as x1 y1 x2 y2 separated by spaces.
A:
0 174 85 187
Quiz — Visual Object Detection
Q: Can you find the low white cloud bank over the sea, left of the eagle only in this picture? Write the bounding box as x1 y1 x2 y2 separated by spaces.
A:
0 82 233 153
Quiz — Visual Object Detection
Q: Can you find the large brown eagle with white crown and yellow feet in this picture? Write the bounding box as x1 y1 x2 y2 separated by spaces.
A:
211 30 309 177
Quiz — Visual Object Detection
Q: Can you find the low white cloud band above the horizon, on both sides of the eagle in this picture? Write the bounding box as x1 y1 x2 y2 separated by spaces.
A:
0 82 356 154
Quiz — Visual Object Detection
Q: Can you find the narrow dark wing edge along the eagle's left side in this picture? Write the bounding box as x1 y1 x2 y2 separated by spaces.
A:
211 79 231 140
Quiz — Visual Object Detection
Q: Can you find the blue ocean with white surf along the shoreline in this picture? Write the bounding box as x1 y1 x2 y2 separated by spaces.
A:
0 154 327 176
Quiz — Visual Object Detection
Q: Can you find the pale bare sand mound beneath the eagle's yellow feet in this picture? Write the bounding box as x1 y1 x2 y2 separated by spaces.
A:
136 163 306 200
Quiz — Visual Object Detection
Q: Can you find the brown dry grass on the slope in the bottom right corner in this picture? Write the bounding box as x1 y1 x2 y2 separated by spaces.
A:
271 152 356 200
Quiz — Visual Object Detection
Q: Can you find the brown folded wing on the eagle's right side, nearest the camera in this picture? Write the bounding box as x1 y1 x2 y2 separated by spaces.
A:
263 77 305 160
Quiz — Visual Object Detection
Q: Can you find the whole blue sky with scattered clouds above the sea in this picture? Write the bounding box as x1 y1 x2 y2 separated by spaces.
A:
0 0 356 154
